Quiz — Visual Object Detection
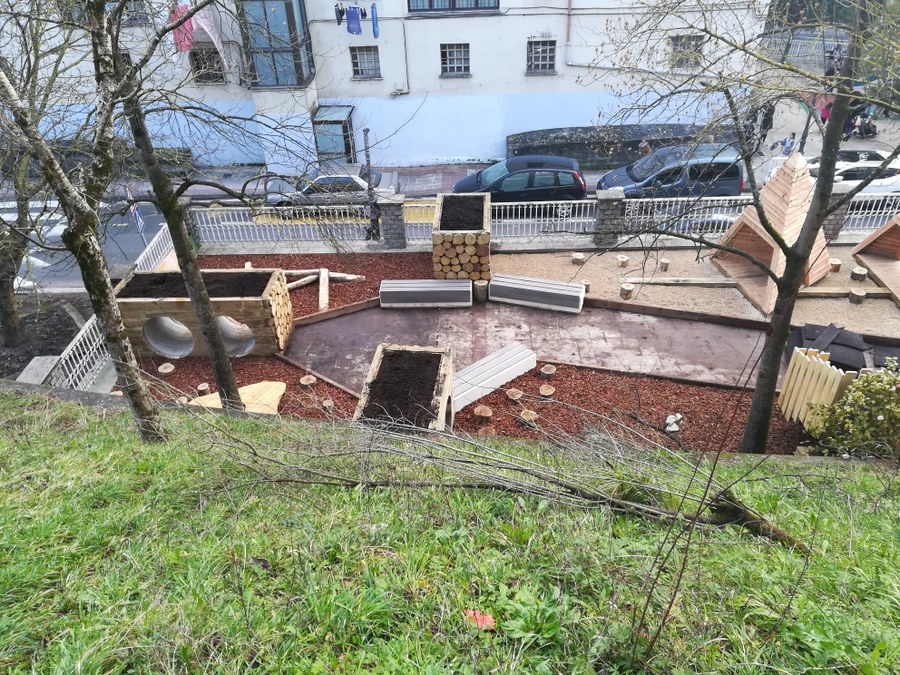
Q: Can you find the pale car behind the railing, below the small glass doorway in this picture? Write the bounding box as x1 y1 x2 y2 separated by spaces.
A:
264 167 400 206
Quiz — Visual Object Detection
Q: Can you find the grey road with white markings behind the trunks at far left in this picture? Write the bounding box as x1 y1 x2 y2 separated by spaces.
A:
0 202 163 292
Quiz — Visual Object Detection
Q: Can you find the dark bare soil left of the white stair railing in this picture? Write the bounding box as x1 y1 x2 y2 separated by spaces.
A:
0 294 93 380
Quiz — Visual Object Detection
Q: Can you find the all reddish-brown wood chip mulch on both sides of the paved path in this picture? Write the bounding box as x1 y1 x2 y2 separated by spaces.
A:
142 253 803 454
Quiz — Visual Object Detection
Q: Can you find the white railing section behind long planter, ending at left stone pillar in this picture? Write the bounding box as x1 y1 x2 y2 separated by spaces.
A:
191 204 369 244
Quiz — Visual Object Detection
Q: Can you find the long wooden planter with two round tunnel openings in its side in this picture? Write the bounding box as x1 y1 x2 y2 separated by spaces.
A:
116 270 293 359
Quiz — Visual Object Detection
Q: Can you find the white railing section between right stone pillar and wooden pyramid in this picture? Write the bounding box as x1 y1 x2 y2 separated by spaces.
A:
621 196 753 234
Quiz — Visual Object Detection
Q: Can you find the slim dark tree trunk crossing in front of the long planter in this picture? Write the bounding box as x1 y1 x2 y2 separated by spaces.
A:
125 90 244 410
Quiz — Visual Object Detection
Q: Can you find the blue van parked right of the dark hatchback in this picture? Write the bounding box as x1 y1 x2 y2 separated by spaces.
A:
597 144 744 198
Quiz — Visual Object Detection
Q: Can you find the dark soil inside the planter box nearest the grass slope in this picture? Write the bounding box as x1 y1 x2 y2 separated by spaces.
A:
362 350 443 429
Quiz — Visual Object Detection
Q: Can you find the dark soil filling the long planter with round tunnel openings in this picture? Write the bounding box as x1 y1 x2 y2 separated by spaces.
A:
116 271 272 298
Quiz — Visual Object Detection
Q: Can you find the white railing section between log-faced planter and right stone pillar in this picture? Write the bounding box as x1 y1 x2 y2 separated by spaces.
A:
491 199 597 240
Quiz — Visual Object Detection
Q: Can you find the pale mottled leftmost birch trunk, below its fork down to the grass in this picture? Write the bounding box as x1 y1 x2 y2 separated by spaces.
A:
63 222 166 442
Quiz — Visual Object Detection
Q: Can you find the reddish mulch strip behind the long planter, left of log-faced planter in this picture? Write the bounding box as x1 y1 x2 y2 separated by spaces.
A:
200 253 433 319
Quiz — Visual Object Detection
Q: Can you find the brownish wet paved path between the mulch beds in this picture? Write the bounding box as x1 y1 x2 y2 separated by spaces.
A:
285 303 763 391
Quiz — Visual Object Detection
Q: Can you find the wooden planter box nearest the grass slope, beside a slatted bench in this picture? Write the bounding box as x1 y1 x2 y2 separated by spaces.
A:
353 344 453 431
